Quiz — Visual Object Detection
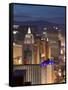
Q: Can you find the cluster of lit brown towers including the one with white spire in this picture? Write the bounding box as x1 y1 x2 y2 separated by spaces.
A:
22 27 50 64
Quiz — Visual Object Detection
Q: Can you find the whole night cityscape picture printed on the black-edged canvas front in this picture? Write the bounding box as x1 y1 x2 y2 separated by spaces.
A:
11 4 66 86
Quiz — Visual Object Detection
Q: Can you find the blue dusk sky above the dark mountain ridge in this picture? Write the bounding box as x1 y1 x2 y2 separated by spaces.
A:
13 4 65 24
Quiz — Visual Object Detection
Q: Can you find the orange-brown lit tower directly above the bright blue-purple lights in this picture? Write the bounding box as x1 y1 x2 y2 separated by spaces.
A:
41 32 51 60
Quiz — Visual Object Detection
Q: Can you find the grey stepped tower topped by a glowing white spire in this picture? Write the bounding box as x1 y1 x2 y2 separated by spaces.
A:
24 27 34 64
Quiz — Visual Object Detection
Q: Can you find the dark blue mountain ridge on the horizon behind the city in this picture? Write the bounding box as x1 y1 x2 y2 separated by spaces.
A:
14 20 65 30
